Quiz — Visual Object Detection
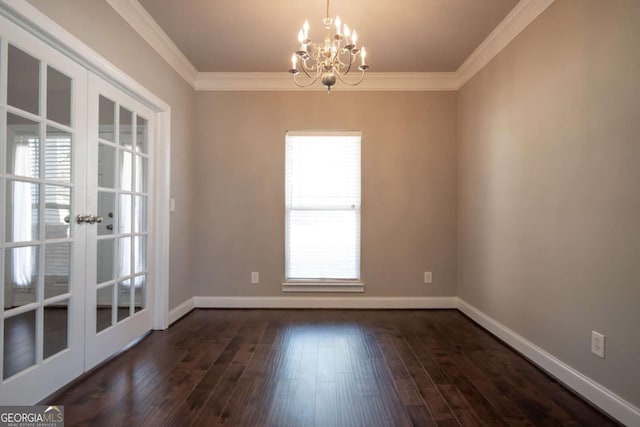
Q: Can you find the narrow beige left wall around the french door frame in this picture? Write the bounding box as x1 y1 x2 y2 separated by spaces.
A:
29 0 195 308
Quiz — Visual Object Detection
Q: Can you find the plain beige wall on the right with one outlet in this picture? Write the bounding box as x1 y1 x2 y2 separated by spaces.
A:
458 0 640 406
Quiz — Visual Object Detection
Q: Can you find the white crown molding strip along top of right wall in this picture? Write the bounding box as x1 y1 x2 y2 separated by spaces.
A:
456 0 554 87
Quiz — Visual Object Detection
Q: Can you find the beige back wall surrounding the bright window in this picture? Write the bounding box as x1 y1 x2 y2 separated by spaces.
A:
194 91 456 296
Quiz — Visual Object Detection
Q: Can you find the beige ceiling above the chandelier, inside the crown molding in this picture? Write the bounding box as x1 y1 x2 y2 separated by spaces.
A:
138 0 518 72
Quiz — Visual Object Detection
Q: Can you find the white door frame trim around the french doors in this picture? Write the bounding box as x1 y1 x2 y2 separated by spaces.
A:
0 0 171 329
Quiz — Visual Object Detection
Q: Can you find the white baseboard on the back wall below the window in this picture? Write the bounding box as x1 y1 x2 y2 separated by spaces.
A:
195 297 457 309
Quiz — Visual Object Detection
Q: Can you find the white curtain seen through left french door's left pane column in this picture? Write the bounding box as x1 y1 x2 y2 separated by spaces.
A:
11 144 34 286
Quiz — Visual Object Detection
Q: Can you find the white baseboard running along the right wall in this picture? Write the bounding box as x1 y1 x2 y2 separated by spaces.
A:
457 298 640 427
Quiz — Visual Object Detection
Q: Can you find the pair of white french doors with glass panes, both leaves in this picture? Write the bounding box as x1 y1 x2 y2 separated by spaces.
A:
0 11 154 405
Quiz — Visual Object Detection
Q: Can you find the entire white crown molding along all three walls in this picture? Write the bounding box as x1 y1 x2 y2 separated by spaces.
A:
106 0 554 91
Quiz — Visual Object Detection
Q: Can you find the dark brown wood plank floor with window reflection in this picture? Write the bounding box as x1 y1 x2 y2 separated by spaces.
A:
46 310 616 427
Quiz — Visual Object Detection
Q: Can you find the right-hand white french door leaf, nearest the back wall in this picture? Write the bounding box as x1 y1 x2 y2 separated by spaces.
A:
84 74 155 369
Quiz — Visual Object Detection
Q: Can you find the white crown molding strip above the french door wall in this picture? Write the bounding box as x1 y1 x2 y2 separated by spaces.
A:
106 0 198 87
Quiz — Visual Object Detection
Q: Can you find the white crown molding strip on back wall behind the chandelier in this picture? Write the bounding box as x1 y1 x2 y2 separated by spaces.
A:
194 72 458 92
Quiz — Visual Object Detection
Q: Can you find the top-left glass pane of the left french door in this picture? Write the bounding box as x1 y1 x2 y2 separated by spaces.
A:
7 45 40 114
